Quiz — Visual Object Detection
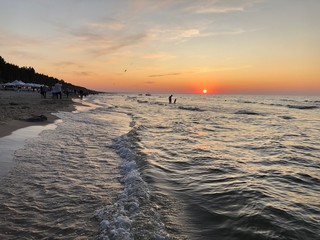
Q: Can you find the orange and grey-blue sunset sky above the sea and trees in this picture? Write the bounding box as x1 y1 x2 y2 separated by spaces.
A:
0 0 320 94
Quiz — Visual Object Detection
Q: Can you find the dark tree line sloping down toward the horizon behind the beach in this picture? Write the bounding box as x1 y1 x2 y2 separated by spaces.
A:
0 56 94 93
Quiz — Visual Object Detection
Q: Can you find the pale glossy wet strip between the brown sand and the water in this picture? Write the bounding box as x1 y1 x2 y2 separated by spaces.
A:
0 119 62 178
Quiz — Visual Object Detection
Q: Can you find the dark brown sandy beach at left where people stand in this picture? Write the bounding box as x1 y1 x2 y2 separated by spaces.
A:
0 91 75 137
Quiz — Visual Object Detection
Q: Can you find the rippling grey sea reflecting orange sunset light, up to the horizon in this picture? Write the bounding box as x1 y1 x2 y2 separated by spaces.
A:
0 93 320 240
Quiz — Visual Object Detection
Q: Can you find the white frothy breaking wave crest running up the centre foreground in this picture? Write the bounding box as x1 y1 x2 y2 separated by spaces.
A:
95 126 169 240
